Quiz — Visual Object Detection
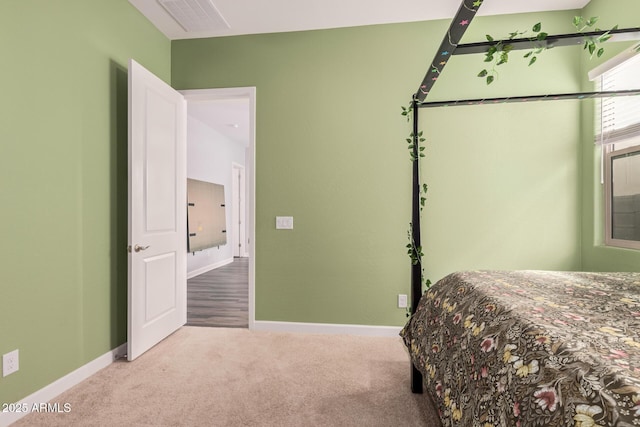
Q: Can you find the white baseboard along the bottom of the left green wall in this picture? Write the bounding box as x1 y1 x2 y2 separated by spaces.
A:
0 343 127 427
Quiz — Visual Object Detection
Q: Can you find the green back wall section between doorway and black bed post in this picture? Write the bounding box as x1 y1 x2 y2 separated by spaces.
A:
172 23 424 325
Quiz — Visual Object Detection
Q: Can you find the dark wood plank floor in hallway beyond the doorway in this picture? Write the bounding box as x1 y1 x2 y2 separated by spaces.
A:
187 258 249 328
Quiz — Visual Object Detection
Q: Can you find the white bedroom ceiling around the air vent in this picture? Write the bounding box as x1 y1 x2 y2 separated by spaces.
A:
129 0 589 40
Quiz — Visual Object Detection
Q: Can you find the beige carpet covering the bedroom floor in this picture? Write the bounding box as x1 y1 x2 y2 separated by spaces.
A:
14 327 440 427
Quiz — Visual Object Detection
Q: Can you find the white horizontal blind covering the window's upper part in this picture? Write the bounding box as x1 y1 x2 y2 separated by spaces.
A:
595 55 640 145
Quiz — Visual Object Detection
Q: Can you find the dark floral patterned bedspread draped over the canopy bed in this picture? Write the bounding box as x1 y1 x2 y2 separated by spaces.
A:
400 271 640 427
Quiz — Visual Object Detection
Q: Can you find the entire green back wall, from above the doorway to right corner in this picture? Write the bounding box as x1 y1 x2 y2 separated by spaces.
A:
172 12 581 325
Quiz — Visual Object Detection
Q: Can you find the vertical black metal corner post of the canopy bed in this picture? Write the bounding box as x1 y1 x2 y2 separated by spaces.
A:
411 95 422 393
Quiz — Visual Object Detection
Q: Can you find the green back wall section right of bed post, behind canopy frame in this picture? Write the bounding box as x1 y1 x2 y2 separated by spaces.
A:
421 11 581 280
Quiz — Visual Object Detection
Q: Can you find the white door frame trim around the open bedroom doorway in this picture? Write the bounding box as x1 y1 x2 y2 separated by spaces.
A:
178 86 256 330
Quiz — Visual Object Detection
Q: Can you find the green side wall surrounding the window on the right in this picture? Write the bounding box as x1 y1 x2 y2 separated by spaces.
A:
582 0 640 271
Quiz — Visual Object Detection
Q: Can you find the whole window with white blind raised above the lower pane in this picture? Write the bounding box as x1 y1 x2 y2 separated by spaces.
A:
596 50 640 249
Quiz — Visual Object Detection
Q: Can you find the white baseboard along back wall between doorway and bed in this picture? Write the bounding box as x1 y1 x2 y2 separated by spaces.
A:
253 320 402 337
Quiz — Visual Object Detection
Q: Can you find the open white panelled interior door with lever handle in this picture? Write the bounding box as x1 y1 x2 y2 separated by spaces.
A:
127 60 187 360
